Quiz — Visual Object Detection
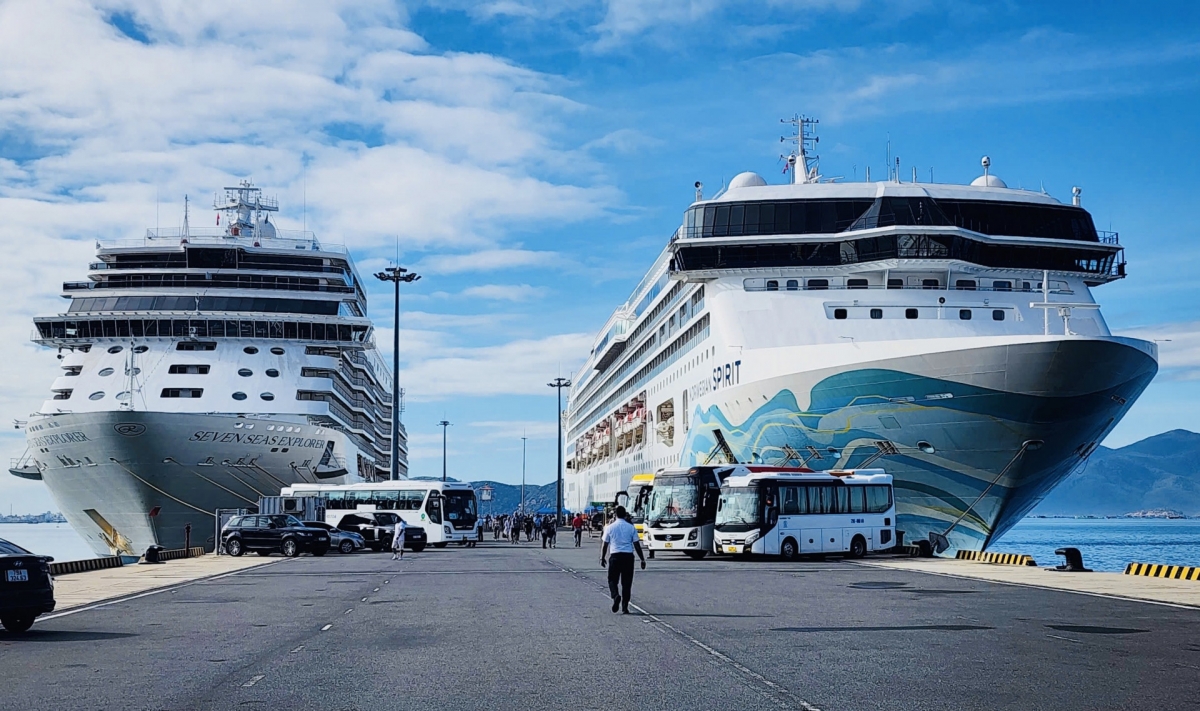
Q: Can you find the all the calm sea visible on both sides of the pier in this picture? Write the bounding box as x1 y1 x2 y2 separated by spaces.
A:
0 519 1200 572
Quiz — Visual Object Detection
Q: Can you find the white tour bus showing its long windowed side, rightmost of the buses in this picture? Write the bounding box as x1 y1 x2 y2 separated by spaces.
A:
715 466 896 560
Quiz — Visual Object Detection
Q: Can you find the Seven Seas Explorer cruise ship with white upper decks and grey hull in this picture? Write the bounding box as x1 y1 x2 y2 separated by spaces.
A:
10 181 408 555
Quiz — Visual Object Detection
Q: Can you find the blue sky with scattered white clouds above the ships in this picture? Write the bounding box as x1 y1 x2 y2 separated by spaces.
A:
0 0 1200 513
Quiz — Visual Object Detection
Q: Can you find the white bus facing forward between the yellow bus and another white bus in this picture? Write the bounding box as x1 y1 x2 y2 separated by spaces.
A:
644 465 737 558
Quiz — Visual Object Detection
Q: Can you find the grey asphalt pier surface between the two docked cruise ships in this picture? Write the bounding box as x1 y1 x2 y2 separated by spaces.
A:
0 536 1200 710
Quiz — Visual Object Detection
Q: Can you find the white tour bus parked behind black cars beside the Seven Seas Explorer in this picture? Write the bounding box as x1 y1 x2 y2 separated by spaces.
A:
282 479 479 548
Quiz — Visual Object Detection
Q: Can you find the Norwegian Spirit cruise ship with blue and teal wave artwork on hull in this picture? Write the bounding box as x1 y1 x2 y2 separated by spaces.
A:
564 116 1158 550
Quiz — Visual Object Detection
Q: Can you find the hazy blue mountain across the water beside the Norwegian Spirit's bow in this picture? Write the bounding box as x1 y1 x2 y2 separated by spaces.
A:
1033 430 1200 516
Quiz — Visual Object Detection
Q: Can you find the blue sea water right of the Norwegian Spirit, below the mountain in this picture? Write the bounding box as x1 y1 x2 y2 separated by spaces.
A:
988 519 1200 573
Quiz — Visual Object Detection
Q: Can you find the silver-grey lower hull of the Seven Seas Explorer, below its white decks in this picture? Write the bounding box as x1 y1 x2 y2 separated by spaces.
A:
28 411 361 555
